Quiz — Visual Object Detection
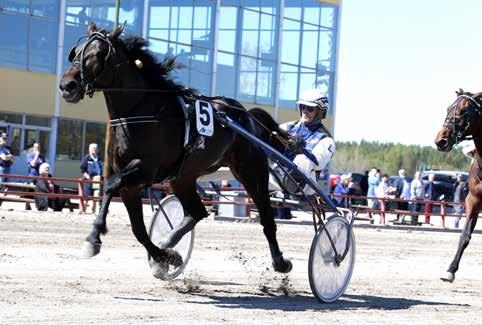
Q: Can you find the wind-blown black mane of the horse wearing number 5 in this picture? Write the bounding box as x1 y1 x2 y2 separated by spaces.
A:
121 36 196 96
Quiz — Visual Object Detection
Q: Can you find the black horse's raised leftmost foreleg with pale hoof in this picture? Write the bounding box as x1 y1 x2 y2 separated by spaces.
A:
82 160 141 258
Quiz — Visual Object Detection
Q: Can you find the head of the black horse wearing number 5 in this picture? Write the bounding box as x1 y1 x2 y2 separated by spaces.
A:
59 23 124 103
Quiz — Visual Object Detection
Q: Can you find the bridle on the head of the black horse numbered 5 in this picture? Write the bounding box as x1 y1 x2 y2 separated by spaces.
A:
69 32 115 98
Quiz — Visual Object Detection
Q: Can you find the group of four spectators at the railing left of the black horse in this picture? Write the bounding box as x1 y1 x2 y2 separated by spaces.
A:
0 132 103 212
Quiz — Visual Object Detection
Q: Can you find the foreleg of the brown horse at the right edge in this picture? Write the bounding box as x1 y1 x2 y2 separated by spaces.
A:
441 193 480 282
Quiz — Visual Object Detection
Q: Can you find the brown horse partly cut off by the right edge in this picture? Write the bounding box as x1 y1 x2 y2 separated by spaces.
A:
435 89 482 282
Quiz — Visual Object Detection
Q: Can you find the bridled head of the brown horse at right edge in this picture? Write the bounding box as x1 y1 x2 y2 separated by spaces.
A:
435 89 482 152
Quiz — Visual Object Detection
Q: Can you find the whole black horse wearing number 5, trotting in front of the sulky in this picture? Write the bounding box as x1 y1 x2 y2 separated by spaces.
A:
60 24 292 275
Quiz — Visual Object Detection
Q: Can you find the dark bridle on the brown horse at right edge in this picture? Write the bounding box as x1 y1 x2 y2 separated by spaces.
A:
443 95 481 144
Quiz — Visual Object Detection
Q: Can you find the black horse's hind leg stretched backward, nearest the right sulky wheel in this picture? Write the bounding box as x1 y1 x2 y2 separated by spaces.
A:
230 150 293 273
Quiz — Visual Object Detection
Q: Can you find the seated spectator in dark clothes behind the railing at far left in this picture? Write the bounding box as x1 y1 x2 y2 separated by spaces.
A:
35 163 67 211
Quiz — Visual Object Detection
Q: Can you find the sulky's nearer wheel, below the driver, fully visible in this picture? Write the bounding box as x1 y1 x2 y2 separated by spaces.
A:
308 216 356 302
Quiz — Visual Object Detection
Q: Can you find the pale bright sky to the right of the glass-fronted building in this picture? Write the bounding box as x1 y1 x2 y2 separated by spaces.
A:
335 0 482 146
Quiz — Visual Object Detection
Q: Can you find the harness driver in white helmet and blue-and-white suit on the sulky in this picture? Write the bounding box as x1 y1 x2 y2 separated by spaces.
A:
272 89 336 194
